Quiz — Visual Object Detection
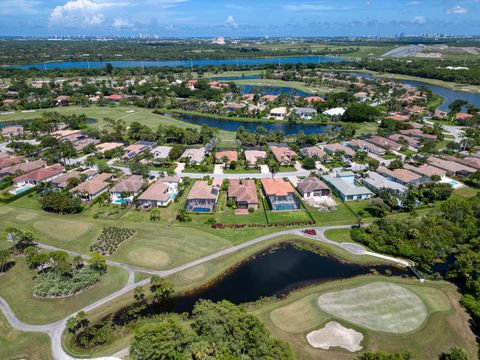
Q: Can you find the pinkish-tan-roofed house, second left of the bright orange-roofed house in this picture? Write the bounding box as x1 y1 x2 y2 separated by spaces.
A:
185 181 220 213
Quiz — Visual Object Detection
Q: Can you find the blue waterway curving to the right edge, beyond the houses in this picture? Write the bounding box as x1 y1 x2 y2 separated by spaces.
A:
349 72 480 111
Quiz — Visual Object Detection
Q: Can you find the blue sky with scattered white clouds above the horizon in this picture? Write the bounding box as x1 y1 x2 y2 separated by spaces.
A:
0 0 480 37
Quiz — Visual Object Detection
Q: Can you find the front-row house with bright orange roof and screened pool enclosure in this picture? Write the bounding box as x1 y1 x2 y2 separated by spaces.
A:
261 178 300 210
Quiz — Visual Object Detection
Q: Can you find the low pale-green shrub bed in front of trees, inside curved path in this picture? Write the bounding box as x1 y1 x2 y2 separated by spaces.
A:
33 266 102 298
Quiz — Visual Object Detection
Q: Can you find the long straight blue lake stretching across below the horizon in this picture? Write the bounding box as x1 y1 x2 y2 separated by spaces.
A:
7 56 346 70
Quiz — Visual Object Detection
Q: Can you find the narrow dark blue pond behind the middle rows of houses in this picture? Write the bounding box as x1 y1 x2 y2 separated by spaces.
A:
175 114 335 135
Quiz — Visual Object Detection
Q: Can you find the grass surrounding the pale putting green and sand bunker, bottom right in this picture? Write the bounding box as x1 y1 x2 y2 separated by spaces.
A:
253 276 477 360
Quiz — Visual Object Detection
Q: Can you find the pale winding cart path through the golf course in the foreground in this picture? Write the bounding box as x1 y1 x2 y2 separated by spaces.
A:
0 225 410 360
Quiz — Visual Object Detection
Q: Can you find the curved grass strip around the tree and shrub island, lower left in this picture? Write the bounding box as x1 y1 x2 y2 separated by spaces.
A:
0 257 128 324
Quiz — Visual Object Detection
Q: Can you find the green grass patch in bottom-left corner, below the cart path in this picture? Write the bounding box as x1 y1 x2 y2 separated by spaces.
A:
0 310 53 360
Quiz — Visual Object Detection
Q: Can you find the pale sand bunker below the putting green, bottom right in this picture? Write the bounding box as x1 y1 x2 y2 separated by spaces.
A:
307 321 363 352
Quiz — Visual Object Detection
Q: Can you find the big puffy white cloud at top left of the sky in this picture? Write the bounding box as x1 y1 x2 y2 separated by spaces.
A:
49 0 128 27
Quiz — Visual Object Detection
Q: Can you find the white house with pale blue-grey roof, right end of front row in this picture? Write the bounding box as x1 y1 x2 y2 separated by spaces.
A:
323 171 373 201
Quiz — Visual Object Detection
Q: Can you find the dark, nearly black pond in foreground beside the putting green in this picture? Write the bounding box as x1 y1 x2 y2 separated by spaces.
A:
150 244 408 312
